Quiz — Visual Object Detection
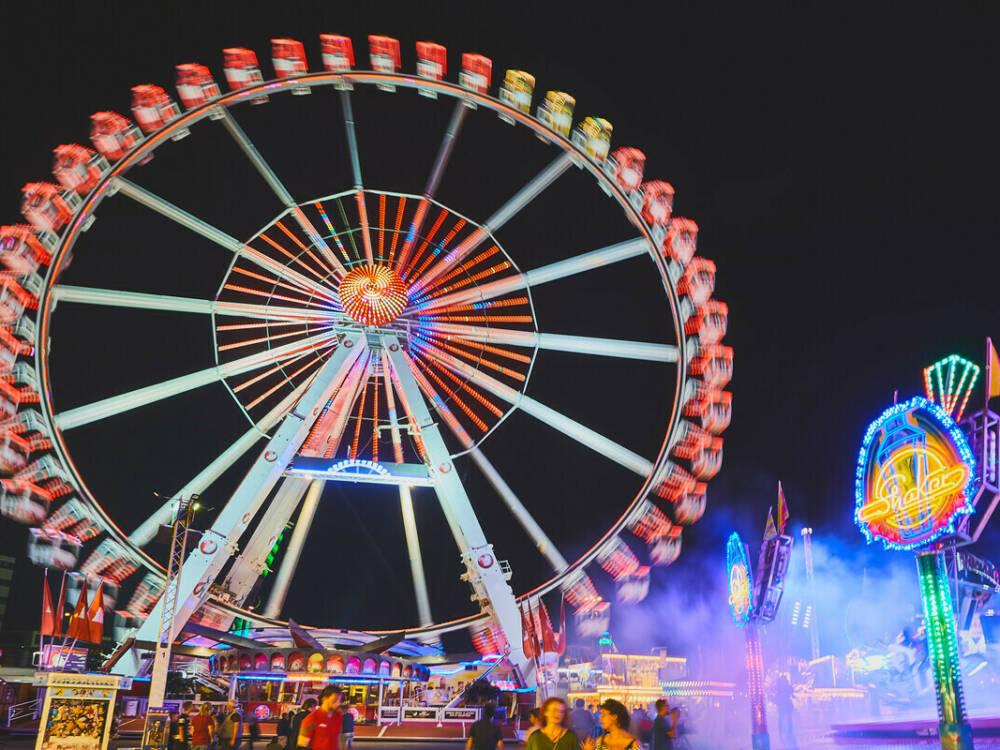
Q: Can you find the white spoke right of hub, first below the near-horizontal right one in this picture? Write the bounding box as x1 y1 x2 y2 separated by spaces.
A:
423 346 653 477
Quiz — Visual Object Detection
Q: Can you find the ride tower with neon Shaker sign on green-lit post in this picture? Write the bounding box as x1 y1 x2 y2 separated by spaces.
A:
855 346 1000 750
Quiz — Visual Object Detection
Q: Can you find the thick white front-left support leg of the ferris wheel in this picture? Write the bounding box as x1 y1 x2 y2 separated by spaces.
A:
136 333 367 656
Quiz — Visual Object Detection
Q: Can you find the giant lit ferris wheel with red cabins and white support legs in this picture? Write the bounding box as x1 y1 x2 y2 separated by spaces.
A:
0 34 733 680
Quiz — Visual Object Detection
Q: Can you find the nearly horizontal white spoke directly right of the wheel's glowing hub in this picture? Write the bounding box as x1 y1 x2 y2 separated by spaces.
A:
426 323 677 362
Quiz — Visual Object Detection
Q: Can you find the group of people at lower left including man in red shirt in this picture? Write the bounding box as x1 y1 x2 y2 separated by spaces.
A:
160 686 354 750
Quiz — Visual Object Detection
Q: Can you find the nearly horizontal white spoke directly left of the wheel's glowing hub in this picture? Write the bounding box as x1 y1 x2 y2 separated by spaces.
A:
51 284 348 323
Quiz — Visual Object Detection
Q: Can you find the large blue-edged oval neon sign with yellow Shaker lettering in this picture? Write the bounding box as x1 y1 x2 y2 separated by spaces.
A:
854 397 975 549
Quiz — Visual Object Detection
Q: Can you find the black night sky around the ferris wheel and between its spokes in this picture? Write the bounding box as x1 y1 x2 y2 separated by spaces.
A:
0 2 1000 656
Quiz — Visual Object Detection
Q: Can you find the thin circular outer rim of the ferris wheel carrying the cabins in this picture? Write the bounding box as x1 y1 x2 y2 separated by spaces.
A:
27 71 697 635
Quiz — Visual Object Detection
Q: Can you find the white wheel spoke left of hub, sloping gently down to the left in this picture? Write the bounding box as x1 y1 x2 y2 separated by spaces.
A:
55 332 336 431
